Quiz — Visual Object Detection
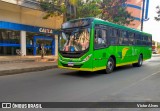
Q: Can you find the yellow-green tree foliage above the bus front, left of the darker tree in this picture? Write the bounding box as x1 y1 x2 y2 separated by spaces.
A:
40 0 101 21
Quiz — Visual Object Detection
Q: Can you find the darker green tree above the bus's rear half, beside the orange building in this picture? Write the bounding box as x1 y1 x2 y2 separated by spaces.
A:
101 0 134 25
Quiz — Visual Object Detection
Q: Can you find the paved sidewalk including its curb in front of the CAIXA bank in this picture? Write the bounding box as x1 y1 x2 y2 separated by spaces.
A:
0 56 57 76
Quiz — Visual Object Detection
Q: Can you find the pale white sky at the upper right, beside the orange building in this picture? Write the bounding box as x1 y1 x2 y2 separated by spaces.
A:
143 0 160 42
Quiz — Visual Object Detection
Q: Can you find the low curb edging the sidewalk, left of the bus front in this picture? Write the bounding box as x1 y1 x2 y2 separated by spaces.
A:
0 65 58 76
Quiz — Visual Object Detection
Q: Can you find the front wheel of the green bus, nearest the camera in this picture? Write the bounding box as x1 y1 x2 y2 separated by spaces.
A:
106 57 115 74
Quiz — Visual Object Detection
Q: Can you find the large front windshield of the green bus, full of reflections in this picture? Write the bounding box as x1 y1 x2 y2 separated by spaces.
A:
59 28 90 52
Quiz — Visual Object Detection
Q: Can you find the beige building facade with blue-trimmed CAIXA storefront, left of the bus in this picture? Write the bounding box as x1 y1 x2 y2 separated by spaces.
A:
0 0 63 56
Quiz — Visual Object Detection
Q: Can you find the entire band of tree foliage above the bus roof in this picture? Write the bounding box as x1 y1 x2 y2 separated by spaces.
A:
40 0 134 25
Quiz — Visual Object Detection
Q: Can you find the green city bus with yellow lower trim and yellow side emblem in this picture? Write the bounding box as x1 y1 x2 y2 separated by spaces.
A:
58 18 152 73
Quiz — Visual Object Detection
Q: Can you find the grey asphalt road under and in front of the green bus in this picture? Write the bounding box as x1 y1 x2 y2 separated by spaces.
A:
0 56 160 111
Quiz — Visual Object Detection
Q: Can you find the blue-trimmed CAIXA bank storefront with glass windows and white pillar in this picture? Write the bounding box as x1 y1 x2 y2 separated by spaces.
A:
0 21 58 56
